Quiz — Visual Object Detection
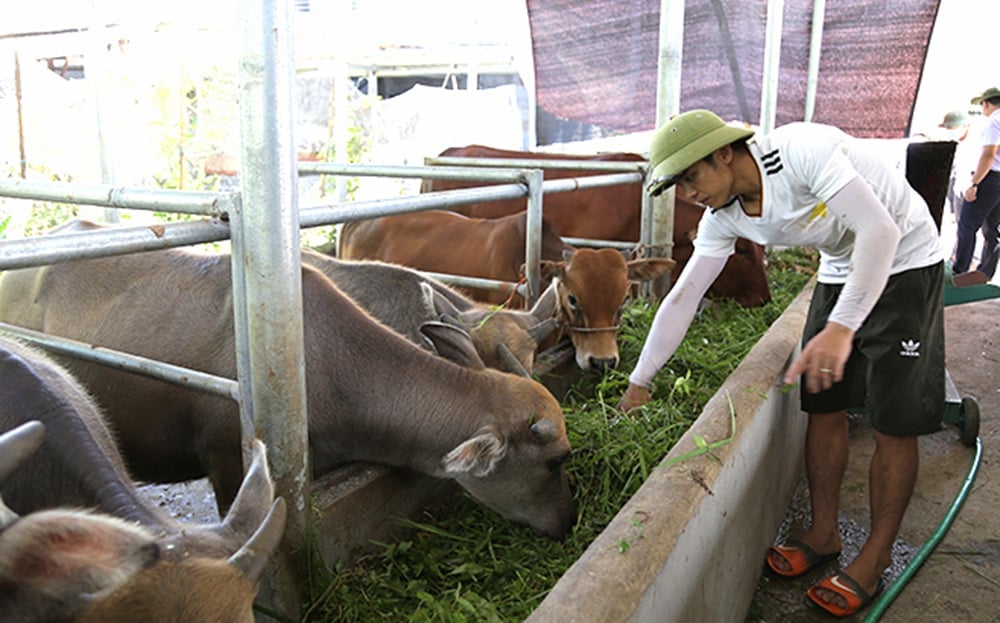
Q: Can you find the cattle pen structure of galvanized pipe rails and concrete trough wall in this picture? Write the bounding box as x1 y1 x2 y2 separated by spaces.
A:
0 0 956 623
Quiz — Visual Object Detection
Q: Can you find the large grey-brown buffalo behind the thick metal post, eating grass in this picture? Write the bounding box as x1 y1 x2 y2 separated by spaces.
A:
0 223 575 538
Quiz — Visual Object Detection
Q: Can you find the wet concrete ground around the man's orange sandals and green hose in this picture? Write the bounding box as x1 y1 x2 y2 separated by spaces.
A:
746 299 1000 623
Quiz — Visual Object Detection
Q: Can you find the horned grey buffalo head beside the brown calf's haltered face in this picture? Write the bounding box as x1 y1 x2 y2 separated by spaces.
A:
421 282 559 372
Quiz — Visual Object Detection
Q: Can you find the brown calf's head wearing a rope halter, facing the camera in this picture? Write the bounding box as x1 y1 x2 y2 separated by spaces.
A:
542 249 674 371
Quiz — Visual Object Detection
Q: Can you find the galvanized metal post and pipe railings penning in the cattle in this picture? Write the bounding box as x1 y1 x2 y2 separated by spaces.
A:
0 0 664 611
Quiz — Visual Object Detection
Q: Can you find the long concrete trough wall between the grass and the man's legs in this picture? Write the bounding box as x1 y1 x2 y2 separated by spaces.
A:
527 285 812 623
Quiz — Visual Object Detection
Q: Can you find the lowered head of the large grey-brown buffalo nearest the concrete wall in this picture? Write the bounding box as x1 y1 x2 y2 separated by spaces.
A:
441 371 576 539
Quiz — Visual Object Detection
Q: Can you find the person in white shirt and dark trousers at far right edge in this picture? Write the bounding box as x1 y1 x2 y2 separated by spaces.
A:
952 87 1000 286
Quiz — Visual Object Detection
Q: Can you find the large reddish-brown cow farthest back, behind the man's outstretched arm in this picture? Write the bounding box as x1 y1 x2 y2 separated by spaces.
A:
421 145 771 307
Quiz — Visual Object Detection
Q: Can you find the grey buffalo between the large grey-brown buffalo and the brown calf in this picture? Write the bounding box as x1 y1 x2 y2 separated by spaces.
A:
302 249 559 372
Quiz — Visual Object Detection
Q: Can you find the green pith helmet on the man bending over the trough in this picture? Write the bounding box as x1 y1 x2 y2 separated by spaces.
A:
646 110 753 197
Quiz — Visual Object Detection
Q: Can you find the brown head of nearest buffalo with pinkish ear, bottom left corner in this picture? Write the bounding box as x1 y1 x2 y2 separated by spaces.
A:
0 421 285 623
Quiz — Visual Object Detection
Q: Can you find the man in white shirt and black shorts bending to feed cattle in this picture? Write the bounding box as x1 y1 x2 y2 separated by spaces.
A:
617 110 945 616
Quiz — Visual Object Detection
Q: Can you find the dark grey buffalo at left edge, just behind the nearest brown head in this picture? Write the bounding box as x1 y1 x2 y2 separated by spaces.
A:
0 336 280 559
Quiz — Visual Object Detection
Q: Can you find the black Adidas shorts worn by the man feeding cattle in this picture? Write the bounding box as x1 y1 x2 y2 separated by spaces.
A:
800 262 945 437
